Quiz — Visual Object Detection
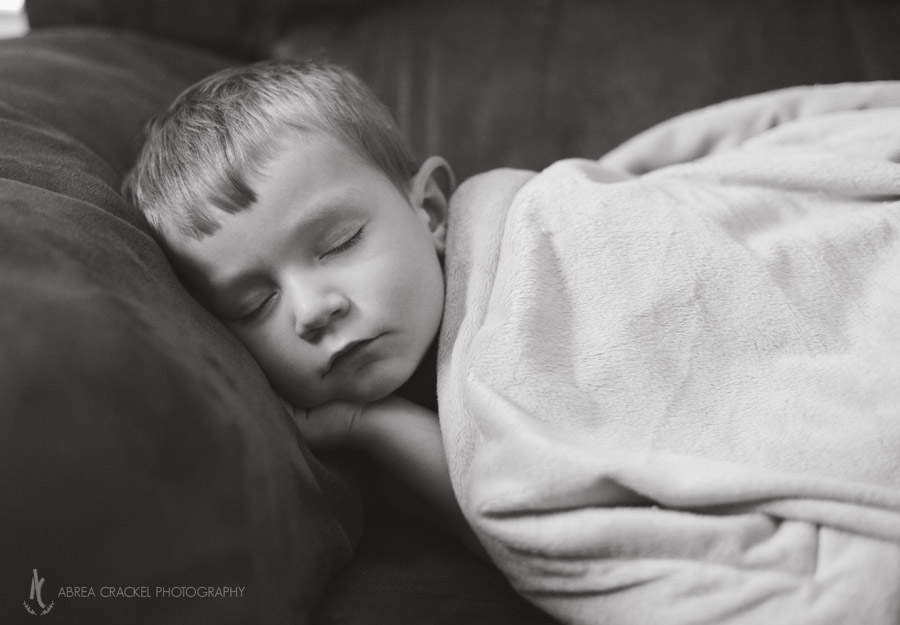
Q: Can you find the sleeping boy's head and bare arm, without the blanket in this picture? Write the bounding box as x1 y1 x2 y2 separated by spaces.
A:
124 62 478 551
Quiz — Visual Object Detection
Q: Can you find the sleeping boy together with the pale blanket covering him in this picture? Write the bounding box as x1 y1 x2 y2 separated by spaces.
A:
127 57 900 623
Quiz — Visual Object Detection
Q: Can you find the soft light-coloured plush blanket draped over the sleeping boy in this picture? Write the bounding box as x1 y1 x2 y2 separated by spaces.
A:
438 83 900 625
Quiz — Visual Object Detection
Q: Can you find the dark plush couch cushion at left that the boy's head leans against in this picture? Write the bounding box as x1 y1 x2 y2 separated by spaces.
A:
0 30 361 623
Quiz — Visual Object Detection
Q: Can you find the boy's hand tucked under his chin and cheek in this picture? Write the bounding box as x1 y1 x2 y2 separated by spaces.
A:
282 398 366 450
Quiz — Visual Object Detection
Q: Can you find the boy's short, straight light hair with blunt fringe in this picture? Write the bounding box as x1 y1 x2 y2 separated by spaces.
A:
122 61 416 241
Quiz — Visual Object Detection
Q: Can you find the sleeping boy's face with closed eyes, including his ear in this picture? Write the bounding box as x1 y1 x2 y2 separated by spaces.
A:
169 133 446 407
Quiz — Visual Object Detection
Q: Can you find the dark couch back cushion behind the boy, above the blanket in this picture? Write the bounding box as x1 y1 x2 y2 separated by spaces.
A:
271 0 900 179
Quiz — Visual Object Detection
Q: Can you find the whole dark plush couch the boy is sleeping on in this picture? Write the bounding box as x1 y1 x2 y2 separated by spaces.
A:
0 0 900 625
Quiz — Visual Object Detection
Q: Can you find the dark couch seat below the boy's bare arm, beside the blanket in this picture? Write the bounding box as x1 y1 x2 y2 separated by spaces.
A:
316 492 557 625
